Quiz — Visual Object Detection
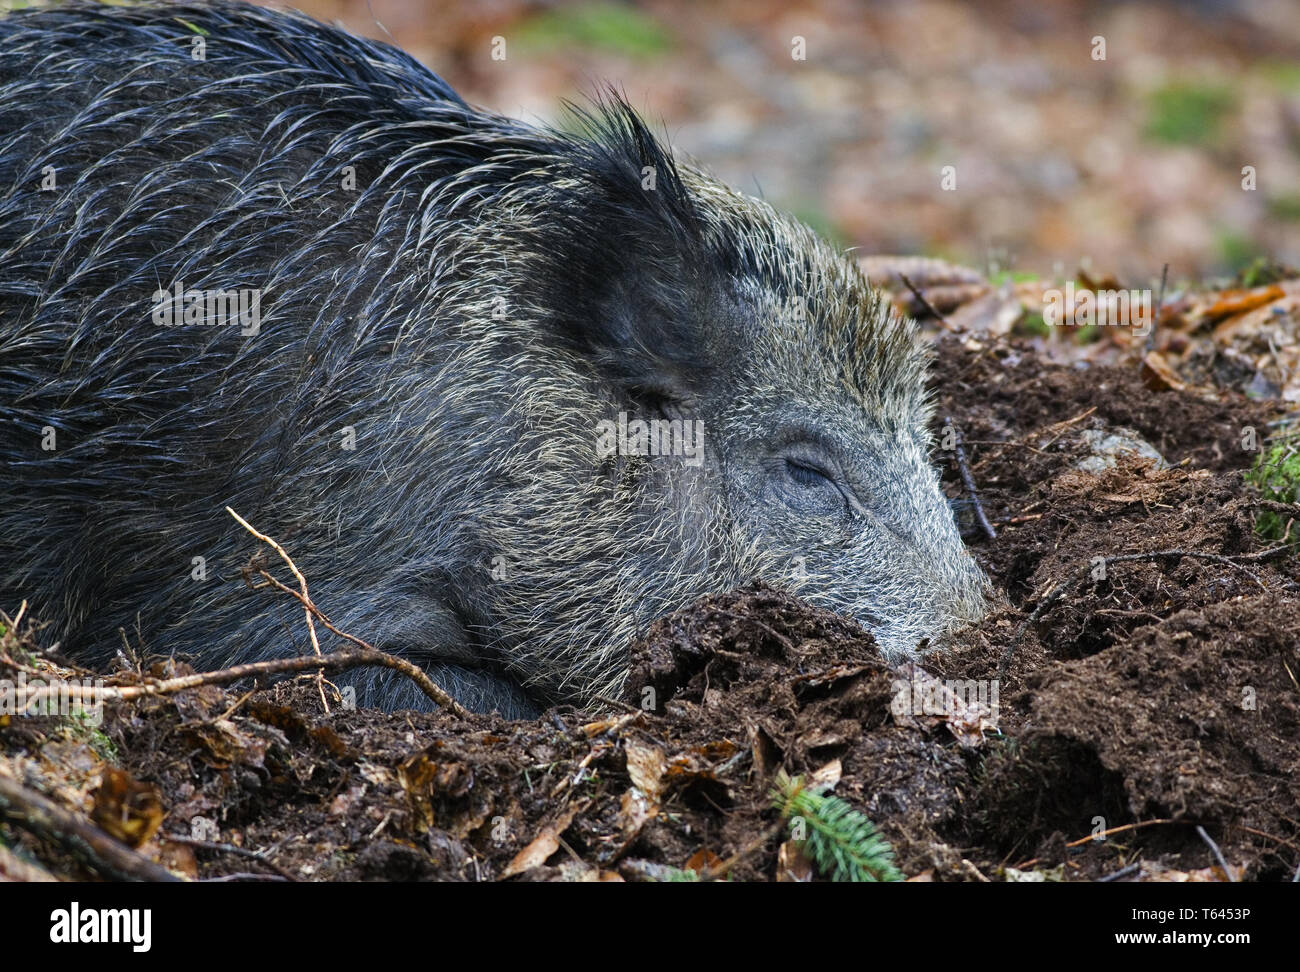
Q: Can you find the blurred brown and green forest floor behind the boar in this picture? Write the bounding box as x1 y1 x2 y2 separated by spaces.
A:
109 0 1300 285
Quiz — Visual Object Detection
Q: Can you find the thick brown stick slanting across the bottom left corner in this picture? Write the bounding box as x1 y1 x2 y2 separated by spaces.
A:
0 772 181 881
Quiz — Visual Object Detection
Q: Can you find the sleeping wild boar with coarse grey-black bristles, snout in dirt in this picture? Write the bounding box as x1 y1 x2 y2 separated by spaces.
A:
0 3 983 713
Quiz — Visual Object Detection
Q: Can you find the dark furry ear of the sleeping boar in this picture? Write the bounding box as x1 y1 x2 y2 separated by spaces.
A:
540 94 718 402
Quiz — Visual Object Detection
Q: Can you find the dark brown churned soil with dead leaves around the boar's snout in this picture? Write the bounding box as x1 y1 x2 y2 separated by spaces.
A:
0 339 1300 881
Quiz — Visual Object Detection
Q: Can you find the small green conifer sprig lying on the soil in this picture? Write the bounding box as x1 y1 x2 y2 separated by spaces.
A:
771 769 904 881
